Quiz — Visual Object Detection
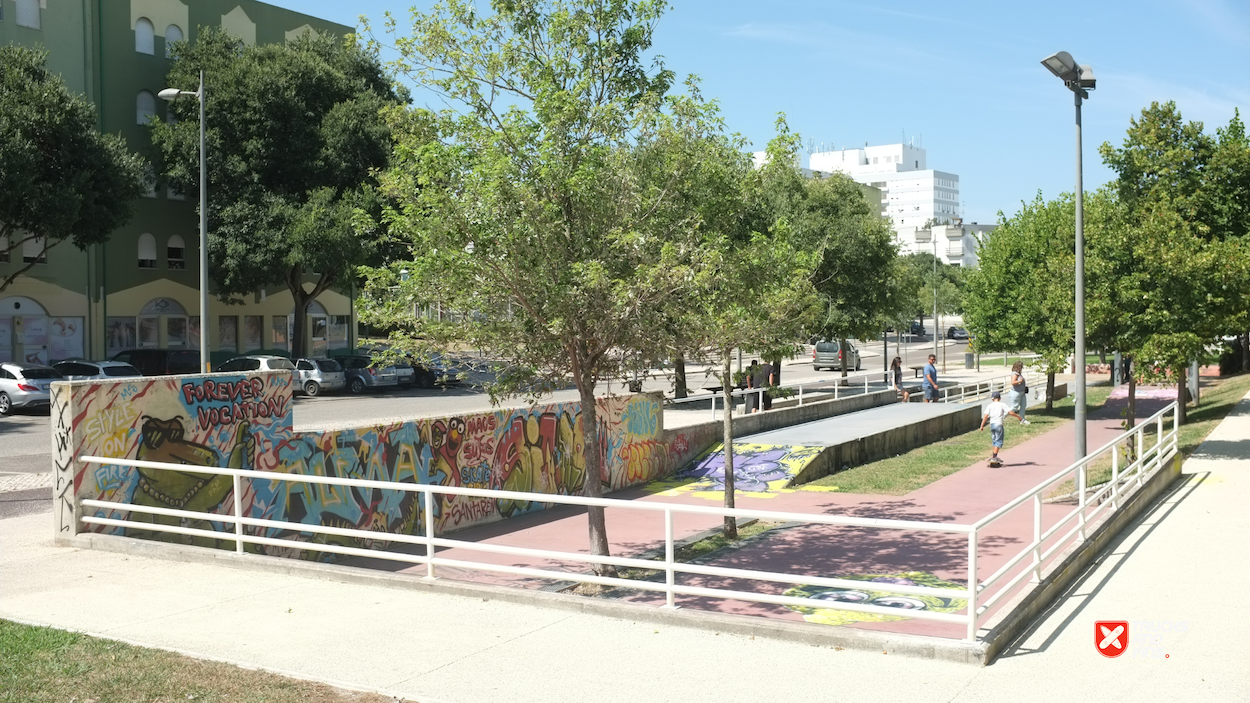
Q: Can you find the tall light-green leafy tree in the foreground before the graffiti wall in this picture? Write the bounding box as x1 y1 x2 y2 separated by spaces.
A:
364 0 720 574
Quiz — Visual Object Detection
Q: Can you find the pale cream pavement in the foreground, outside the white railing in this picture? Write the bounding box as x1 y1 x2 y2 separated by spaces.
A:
0 395 1250 703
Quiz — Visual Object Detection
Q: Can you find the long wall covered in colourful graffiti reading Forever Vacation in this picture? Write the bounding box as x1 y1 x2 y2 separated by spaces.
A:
56 374 691 558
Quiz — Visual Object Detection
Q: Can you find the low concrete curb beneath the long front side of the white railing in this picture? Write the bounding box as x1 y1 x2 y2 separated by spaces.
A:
55 534 989 665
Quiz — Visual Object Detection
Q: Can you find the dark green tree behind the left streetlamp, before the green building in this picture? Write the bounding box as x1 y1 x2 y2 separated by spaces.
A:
151 28 406 355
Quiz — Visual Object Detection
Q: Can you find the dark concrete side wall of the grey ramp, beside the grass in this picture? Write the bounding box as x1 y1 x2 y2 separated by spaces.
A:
789 405 981 487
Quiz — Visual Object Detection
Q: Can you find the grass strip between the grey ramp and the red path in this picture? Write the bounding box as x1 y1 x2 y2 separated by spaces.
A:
806 382 1111 495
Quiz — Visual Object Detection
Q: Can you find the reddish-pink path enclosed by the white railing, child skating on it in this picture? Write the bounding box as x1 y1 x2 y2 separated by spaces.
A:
348 390 1170 638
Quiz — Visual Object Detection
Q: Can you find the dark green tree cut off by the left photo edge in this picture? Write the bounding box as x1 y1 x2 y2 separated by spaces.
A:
0 45 146 291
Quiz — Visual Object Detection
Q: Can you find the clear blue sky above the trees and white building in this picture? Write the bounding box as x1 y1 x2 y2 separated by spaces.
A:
269 0 1250 223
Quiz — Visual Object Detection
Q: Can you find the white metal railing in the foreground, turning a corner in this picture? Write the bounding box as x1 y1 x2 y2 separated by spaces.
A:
79 403 1178 642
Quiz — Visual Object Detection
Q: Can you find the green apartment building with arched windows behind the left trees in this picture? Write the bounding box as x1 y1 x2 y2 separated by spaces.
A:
0 0 355 363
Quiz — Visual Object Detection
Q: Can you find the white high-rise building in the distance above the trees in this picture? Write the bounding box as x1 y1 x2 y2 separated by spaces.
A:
809 144 993 266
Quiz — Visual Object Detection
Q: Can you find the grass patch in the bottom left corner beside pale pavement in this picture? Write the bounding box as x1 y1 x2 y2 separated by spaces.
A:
0 620 396 703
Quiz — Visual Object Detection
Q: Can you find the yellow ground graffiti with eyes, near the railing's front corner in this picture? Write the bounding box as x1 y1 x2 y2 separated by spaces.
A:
785 572 968 625
